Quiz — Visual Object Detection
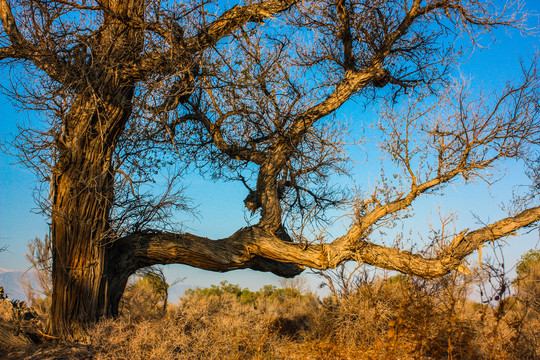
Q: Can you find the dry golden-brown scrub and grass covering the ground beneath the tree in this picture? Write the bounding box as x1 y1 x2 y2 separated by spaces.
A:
0 265 540 360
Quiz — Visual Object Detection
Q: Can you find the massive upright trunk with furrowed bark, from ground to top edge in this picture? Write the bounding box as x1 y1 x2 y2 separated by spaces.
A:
50 0 144 338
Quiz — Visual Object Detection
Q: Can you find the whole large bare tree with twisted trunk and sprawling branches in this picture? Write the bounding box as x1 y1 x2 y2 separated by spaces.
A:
0 0 540 336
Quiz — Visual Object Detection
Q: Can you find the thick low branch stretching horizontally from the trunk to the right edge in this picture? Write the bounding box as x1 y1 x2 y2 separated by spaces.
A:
117 207 540 278
